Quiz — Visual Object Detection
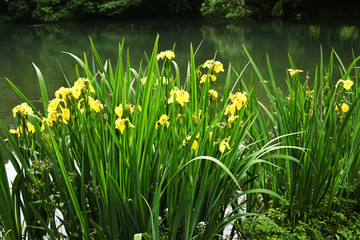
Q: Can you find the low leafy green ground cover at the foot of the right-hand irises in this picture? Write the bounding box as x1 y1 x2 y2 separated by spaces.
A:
235 200 360 240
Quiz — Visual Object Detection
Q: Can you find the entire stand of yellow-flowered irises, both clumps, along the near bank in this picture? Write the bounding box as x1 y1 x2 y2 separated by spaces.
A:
0 35 360 239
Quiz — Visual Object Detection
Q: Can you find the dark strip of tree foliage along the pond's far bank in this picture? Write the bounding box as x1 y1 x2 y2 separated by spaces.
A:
0 0 360 21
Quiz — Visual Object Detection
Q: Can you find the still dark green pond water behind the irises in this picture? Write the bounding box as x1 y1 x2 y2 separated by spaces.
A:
0 20 360 126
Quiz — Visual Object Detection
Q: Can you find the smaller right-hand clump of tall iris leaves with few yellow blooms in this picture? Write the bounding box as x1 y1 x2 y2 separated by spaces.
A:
245 46 360 222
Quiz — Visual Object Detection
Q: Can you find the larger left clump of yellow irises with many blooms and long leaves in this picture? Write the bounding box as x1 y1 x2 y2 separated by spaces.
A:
0 38 292 239
